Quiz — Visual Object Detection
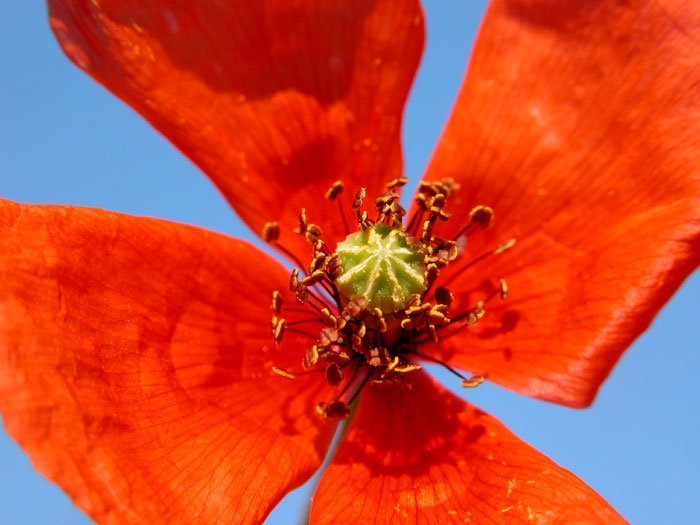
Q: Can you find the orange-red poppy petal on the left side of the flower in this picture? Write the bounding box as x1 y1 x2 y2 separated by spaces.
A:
0 201 334 523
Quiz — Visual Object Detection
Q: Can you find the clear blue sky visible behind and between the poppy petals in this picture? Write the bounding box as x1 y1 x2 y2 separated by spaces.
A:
0 0 700 525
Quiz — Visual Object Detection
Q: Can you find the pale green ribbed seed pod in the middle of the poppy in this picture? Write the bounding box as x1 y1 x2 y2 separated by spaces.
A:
335 225 426 314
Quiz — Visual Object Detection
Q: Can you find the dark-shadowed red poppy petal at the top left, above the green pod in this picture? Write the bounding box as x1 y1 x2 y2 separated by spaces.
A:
49 0 423 257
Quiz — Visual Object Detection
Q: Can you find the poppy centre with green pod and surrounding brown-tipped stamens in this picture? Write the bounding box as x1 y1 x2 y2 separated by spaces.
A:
263 179 515 419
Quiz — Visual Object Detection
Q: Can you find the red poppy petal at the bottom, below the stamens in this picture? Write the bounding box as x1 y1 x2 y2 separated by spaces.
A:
310 374 624 525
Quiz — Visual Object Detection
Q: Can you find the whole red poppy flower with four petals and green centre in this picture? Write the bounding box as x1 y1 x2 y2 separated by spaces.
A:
0 0 700 523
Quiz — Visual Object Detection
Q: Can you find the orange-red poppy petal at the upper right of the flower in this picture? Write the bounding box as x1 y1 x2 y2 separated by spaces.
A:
428 0 700 406
